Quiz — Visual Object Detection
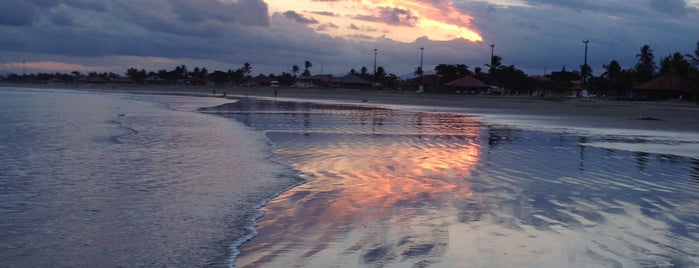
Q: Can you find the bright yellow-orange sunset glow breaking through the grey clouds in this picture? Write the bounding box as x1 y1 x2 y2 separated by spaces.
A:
267 0 483 43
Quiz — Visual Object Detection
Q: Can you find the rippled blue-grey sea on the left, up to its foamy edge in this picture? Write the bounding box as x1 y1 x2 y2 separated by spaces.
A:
0 88 301 267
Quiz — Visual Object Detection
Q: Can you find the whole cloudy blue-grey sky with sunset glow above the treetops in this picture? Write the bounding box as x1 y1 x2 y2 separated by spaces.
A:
0 0 699 76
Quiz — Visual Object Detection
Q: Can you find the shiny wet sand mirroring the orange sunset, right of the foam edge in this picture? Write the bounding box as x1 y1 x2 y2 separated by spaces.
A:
204 98 699 267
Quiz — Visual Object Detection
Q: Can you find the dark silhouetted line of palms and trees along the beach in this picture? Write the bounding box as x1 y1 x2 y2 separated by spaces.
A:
0 42 699 98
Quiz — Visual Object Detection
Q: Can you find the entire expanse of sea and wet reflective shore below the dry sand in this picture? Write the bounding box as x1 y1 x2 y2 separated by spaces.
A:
5 88 699 267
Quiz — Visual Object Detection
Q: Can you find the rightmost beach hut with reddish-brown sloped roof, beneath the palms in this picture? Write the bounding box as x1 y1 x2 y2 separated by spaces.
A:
631 74 685 100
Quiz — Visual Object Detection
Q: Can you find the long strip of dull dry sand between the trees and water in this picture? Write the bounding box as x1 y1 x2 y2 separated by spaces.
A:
5 84 699 133
